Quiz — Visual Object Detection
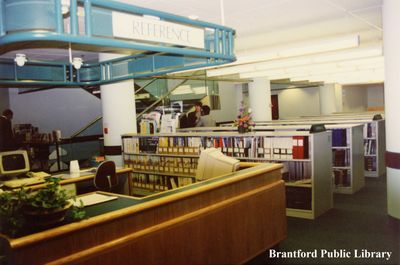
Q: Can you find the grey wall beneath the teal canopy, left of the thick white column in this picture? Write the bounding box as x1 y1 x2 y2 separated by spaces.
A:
10 88 101 137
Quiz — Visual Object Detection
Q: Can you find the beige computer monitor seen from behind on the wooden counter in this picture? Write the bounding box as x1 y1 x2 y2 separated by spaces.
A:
196 148 239 180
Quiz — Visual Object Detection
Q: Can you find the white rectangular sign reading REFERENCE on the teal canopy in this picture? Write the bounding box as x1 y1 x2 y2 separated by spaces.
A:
112 12 204 49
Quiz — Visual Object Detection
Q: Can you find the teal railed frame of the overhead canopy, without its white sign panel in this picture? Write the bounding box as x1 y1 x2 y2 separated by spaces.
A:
0 0 235 87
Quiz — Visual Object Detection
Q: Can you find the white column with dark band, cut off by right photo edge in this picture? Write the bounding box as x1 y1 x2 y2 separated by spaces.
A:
383 0 400 219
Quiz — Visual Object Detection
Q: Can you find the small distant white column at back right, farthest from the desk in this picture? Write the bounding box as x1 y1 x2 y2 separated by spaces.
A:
319 84 343 115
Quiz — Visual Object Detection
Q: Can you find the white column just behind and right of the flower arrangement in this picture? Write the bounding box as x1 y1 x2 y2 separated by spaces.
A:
249 78 272 121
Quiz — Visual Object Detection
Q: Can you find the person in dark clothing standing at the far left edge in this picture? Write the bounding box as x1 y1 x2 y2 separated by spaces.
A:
0 109 16 151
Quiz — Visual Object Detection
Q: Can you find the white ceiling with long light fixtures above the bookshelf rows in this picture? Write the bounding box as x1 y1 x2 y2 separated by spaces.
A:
116 0 383 84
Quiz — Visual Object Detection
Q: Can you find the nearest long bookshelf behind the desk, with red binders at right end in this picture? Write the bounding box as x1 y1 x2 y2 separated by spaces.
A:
122 131 332 219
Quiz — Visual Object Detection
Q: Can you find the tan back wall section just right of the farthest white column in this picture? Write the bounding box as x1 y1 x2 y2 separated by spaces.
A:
343 86 368 112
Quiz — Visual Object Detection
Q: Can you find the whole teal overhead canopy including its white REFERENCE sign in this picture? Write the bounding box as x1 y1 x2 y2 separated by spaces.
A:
0 0 235 86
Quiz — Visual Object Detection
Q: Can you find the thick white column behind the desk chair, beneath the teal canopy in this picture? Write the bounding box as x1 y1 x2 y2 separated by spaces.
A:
99 54 137 166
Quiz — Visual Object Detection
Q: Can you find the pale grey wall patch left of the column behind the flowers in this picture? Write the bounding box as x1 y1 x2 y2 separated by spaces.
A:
210 82 239 122
